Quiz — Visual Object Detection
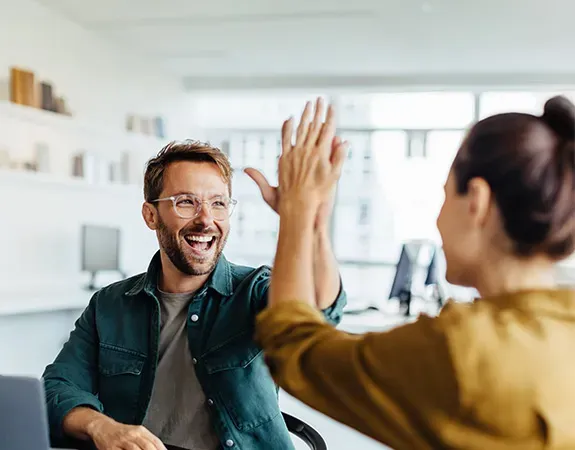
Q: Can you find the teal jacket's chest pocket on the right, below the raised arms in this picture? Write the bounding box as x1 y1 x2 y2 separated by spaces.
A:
203 332 280 431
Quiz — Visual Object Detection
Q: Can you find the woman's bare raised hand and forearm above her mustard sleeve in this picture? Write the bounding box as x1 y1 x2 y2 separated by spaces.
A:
269 99 346 306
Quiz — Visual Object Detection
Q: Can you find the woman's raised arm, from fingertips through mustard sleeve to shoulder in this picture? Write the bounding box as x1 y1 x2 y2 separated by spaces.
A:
256 101 457 449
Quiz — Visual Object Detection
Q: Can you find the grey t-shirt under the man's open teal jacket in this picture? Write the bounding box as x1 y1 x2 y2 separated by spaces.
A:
143 292 220 450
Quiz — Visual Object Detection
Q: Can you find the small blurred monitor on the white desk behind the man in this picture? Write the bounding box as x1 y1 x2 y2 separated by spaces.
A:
82 225 122 290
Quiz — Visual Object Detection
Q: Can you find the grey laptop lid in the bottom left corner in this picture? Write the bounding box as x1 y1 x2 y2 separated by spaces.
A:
0 375 65 450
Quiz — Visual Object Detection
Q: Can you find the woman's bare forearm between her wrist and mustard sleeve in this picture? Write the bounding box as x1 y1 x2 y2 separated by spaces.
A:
269 202 317 305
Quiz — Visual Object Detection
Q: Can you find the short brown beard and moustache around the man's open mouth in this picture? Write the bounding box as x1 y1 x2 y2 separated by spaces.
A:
158 219 228 276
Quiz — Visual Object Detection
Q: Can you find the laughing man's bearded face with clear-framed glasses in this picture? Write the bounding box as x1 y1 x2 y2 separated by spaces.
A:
146 161 230 275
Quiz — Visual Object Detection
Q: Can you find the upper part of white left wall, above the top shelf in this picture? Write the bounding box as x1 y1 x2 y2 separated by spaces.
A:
0 0 191 134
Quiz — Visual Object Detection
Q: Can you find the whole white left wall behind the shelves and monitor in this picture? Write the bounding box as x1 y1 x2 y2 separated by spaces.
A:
0 0 191 292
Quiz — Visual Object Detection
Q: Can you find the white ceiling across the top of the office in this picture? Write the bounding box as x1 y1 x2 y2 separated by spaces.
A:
35 0 575 87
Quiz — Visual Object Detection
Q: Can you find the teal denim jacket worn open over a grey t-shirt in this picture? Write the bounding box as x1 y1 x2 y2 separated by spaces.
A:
43 253 346 450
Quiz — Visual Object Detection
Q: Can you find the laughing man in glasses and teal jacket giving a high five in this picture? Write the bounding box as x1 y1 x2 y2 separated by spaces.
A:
44 134 345 450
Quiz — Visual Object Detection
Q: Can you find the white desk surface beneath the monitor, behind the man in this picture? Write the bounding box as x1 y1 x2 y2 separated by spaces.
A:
0 289 94 316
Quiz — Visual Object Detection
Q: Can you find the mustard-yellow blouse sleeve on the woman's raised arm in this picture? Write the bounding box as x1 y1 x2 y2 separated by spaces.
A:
256 301 458 449
